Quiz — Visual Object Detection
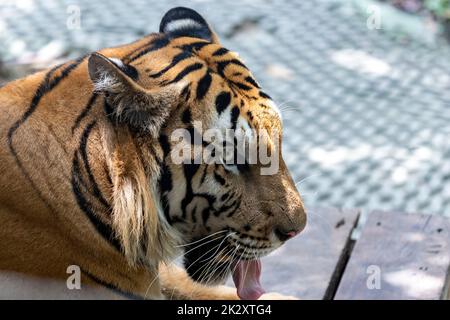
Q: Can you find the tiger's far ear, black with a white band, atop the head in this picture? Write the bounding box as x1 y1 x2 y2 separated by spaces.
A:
159 7 219 43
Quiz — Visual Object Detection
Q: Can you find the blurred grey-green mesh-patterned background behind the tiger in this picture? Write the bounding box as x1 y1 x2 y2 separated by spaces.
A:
0 0 450 225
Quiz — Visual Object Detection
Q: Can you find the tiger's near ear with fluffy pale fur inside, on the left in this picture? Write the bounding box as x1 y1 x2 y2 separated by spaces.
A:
88 53 180 137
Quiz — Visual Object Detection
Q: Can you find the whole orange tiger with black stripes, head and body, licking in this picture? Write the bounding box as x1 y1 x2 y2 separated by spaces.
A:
0 7 306 299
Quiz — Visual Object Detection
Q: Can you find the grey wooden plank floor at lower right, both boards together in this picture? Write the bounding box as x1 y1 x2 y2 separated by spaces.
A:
263 209 450 299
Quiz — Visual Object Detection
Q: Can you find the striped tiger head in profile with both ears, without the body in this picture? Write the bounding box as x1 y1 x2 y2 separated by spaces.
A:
89 8 306 298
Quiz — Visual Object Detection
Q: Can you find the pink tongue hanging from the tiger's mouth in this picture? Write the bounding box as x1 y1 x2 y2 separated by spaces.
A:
233 260 265 300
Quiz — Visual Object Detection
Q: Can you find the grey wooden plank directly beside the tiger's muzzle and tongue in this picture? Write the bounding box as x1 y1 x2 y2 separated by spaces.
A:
229 208 359 299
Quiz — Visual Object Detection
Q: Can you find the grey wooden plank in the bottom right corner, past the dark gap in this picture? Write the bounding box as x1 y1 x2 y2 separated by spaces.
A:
335 212 450 300
